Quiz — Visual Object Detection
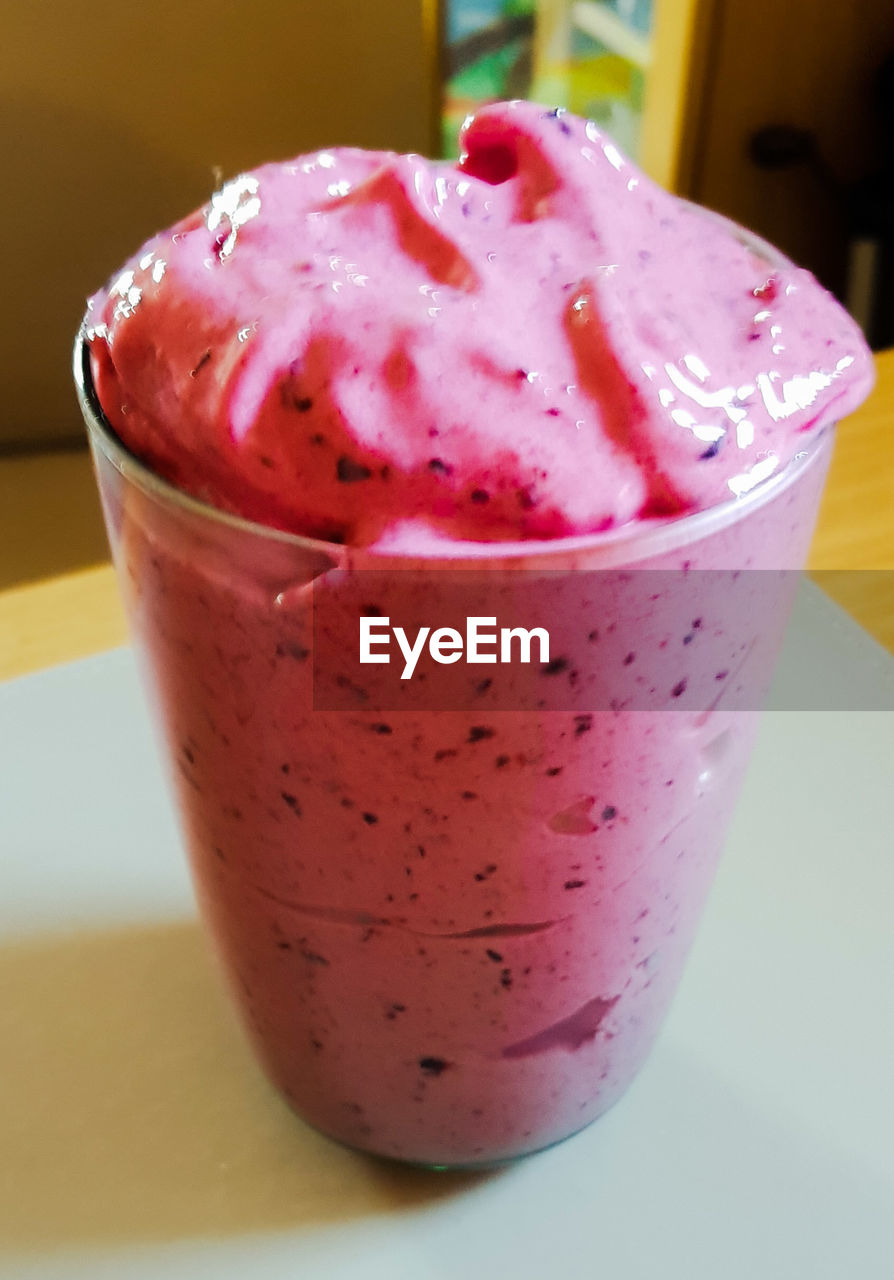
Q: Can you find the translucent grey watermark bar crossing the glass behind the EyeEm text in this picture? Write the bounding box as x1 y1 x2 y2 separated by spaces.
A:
313 568 894 716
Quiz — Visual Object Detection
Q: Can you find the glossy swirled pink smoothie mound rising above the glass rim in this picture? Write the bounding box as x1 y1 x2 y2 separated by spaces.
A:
87 102 872 545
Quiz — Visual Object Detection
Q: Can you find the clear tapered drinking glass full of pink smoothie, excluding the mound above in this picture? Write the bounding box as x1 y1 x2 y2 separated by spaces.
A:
76 340 833 1167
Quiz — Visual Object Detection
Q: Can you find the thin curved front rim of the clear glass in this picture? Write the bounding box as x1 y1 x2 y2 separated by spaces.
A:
73 330 835 568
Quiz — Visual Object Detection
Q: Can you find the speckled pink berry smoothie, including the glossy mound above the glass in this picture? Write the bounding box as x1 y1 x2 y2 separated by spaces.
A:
81 104 871 1165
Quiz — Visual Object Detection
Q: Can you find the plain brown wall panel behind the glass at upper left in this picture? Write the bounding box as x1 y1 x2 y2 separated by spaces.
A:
0 0 432 448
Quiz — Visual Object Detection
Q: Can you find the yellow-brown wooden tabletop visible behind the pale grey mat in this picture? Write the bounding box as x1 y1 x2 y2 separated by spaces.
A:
0 351 894 678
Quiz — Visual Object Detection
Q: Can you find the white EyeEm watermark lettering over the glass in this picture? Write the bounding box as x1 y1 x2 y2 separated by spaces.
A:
360 614 549 680
